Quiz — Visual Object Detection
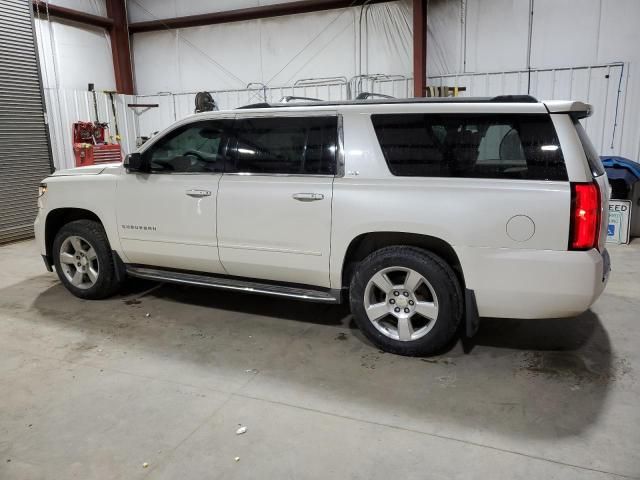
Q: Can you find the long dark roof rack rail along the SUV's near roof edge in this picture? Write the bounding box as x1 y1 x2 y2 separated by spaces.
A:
238 95 539 110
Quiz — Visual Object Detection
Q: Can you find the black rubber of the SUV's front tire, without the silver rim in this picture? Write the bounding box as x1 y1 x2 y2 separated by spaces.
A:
52 220 120 300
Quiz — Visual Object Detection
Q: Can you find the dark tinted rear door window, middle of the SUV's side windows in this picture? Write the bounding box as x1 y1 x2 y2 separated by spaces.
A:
228 117 338 175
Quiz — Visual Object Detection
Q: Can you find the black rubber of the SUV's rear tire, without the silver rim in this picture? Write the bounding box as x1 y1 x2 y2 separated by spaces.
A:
349 246 464 356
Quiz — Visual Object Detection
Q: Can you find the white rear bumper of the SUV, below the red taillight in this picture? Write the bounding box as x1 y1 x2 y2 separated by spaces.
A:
456 248 610 318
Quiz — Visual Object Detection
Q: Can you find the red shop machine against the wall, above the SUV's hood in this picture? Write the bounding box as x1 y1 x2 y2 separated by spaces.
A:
73 83 122 167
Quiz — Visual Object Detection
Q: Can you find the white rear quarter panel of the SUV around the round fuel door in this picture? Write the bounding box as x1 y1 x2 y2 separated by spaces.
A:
331 109 571 288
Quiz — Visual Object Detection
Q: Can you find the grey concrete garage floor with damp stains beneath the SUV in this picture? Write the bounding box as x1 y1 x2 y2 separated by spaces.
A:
0 241 640 480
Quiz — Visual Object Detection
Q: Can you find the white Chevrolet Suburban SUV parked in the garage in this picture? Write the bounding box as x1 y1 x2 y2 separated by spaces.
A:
35 96 609 355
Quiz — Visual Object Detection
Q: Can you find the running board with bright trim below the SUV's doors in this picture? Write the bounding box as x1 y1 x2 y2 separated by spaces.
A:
126 265 340 303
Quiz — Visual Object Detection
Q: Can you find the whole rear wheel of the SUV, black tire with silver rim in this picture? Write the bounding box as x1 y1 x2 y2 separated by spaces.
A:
349 246 463 356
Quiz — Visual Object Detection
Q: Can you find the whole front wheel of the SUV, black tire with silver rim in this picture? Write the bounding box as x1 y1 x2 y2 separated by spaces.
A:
52 220 120 300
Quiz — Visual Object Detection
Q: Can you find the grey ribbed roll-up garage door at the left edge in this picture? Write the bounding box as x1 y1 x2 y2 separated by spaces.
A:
0 0 51 243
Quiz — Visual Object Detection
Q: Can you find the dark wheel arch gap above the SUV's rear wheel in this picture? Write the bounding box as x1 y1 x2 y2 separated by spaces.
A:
341 231 465 289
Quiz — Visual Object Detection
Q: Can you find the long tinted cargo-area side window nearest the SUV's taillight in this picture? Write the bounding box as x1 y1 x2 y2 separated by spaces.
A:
371 114 568 180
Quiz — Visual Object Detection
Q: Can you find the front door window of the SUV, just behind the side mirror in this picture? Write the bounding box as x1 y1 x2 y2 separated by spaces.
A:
144 121 225 173
